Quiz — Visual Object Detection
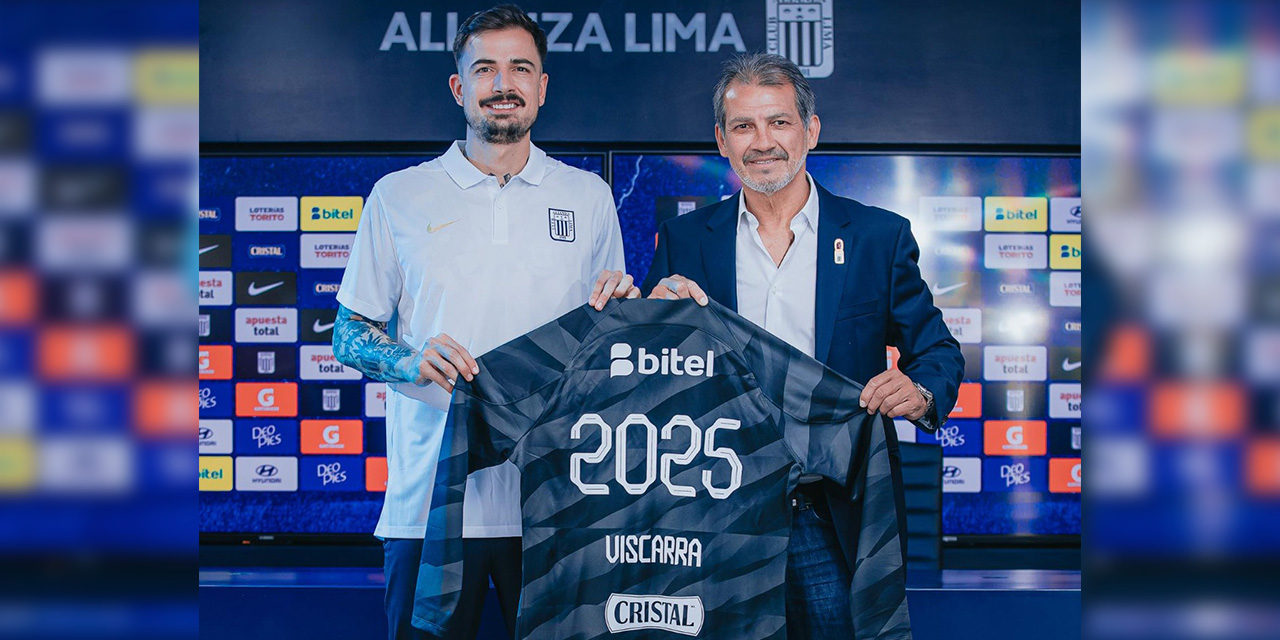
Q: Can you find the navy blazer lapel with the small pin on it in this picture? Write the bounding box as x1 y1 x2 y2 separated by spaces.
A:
813 182 854 362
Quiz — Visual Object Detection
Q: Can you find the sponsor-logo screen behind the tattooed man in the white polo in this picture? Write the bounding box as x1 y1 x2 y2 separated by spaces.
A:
197 154 604 534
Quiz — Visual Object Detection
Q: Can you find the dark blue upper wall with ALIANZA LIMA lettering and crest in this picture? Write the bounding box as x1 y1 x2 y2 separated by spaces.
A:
200 0 1080 146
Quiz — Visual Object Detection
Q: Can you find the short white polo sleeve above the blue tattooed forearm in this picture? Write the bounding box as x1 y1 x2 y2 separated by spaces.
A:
338 184 403 323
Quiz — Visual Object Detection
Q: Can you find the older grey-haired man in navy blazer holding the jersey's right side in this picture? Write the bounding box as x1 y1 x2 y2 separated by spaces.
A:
643 54 964 640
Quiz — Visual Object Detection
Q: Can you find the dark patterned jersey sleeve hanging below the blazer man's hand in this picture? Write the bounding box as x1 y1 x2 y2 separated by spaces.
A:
733 305 911 640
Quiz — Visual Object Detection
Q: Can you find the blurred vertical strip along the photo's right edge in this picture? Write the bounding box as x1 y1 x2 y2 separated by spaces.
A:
1080 1 1280 637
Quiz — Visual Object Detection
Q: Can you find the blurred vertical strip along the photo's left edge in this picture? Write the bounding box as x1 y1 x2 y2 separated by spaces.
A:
0 0 200 639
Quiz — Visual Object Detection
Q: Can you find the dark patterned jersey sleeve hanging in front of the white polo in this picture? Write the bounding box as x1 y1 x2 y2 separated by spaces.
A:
412 307 602 636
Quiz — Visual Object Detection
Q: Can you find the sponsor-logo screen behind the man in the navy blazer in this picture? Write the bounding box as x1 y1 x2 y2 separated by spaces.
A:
612 153 1082 535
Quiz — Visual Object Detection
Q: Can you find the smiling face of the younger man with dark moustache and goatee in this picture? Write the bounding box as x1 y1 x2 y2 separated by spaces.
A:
449 28 547 145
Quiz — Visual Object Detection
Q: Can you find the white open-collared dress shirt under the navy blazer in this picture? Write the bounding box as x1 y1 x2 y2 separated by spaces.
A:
735 173 818 357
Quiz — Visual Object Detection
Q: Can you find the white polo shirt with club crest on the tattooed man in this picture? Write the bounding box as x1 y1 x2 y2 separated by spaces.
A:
338 142 625 538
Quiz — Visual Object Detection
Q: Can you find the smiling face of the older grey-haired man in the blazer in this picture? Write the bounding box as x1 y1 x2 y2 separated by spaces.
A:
716 82 820 196
